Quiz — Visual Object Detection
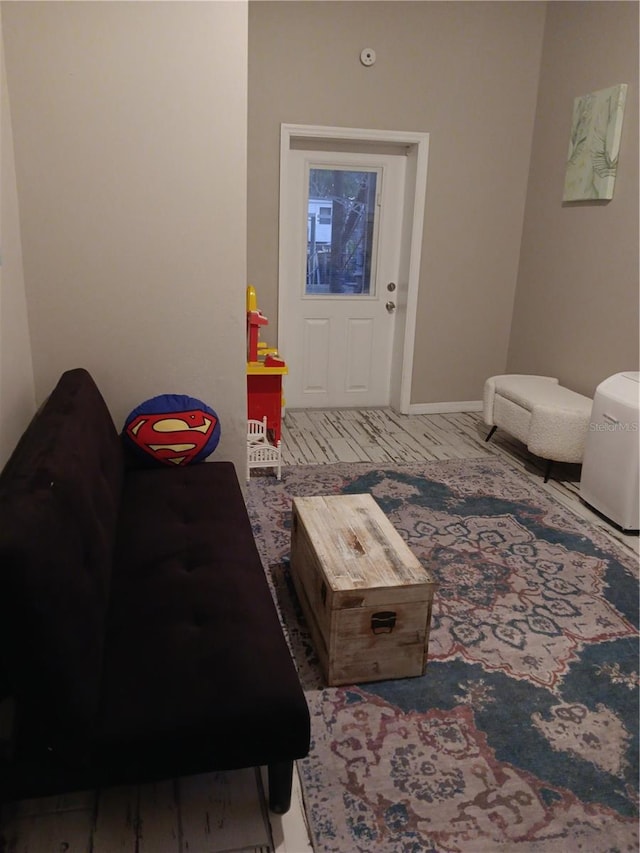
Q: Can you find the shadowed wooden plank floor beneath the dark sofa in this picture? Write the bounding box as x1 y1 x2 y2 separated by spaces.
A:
0 769 280 853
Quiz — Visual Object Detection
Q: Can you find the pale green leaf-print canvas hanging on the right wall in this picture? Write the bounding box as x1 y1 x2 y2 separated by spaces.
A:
562 83 627 201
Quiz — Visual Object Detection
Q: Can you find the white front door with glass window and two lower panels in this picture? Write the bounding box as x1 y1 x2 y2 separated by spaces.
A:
278 149 406 408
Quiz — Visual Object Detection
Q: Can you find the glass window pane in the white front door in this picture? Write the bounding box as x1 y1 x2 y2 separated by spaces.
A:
305 167 378 296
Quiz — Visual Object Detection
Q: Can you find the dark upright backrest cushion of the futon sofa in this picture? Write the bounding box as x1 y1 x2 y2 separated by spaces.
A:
0 370 122 759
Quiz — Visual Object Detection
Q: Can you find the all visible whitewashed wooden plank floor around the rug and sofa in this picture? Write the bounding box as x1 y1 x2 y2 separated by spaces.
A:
0 409 638 853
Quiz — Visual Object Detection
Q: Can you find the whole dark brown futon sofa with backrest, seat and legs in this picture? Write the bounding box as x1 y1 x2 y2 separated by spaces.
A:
0 369 309 813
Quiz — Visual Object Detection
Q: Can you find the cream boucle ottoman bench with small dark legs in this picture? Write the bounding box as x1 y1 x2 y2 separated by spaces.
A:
483 373 593 483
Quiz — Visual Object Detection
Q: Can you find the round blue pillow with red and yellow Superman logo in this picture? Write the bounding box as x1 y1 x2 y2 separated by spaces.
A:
123 394 220 466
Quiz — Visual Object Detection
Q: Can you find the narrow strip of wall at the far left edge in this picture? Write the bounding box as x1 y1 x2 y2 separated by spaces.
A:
0 5 35 469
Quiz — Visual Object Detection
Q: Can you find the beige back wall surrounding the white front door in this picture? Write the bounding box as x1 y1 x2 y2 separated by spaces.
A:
248 0 547 405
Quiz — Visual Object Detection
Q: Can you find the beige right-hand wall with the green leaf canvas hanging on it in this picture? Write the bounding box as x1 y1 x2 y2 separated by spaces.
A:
507 2 640 396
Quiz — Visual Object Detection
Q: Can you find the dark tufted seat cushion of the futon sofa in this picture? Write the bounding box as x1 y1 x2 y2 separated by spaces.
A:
99 462 309 778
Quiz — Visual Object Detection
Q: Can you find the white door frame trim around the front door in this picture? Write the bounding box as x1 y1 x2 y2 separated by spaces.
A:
278 123 429 414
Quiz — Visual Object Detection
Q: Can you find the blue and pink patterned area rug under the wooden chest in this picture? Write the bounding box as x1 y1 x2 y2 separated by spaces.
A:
248 460 639 853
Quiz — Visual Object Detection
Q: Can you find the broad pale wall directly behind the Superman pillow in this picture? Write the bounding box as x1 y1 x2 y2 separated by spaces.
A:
3 2 247 476
